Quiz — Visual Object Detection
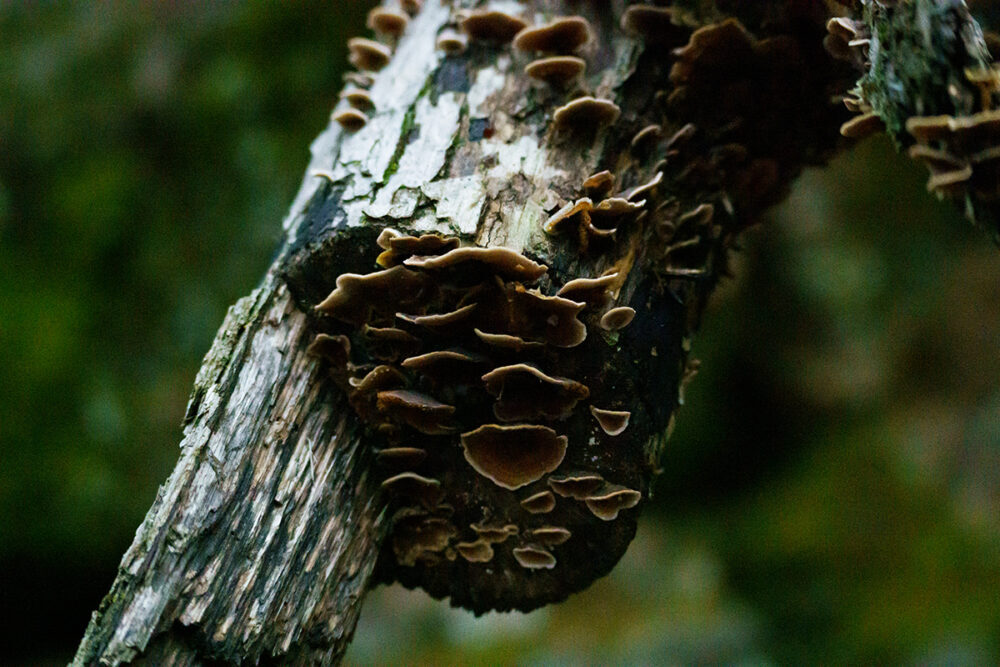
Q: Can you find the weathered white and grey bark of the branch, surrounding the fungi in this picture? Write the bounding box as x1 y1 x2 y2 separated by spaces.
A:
68 0 992 665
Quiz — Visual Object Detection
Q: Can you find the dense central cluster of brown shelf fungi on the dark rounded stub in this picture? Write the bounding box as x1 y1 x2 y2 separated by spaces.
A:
311 228 642 570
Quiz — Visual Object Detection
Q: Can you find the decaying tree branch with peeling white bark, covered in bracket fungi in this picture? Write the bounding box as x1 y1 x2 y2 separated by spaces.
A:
75 0 1000 665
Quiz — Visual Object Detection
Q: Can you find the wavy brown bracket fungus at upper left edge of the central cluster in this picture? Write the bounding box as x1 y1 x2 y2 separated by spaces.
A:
316 266 429 326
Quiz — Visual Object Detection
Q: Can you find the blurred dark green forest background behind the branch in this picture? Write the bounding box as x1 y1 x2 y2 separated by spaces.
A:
0 1 1000 665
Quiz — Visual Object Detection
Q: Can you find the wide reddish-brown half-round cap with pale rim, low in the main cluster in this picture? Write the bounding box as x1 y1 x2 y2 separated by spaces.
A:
462 424 567 490
